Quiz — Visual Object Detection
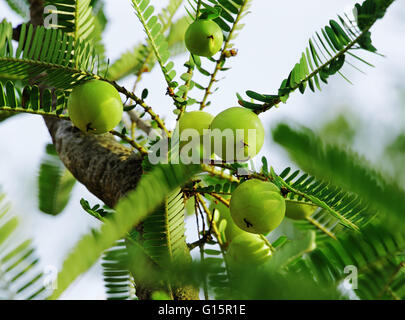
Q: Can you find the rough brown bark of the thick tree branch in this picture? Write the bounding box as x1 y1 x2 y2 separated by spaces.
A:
24 0 198 300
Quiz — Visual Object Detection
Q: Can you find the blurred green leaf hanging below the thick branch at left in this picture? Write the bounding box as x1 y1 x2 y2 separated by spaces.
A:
38 144 76 216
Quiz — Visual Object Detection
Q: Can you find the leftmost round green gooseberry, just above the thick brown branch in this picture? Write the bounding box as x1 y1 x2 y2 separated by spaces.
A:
68 80 123 134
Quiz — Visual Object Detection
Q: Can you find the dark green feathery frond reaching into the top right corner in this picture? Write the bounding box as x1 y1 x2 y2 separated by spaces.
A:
238 0 394 112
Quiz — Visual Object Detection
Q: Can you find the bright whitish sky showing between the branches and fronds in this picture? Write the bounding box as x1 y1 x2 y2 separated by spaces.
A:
0 0 405 299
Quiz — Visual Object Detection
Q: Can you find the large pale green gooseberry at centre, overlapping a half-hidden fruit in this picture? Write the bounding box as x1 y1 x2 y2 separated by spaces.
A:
211 107 265 162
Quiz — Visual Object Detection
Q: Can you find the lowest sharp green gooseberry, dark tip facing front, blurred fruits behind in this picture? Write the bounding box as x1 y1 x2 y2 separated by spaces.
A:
230 180 286 234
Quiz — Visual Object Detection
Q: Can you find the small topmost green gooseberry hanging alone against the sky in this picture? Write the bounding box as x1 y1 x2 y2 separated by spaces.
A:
185 20 224 57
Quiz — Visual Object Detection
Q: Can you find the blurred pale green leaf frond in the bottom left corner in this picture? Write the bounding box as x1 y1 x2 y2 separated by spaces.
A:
0 195 46 300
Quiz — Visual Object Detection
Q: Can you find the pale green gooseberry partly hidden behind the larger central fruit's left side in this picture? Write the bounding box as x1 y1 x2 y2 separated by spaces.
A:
178 111 214 158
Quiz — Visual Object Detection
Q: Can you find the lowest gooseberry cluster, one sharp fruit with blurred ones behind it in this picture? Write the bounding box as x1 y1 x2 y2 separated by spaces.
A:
212 179 316 267
